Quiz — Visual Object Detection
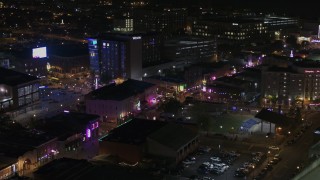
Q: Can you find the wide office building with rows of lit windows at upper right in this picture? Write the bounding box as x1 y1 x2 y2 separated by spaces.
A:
192 16 298 42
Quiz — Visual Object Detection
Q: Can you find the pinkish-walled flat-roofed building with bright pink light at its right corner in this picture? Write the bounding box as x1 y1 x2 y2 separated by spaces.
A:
85 79 157 133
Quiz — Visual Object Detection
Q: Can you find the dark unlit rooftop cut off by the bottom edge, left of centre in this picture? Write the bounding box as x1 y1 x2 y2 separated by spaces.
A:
34 158 159 180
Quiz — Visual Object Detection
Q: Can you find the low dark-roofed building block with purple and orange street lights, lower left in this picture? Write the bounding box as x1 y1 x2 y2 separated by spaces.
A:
0 112 99 179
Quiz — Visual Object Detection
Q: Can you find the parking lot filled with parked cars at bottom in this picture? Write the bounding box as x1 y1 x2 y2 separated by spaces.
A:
180 146 266 180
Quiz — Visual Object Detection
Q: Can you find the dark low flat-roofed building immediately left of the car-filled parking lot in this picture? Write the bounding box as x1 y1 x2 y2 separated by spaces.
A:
100 119 199 166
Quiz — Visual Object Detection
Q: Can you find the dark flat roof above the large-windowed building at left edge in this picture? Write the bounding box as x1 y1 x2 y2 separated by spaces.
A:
0 67 38 86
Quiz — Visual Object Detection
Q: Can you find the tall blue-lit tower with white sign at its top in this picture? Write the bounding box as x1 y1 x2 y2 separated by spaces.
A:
88 33 161 80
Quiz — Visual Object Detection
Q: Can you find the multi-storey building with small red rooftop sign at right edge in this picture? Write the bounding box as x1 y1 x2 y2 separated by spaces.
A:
261 61 320 105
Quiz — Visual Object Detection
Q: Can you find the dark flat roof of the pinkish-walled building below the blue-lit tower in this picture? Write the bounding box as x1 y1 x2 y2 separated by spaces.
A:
87 79 155 101
